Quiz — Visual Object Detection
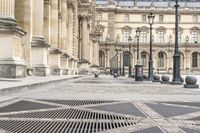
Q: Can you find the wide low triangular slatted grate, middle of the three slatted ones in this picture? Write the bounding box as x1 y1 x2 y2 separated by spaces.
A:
1 108 134 120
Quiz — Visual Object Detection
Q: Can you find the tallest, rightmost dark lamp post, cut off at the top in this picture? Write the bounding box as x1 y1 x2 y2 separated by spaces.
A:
172 0 183 85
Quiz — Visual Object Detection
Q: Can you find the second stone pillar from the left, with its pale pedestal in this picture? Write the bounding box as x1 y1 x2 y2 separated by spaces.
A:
31 0 50 76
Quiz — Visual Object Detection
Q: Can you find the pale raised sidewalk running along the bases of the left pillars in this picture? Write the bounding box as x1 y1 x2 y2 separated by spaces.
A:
0 75 82 91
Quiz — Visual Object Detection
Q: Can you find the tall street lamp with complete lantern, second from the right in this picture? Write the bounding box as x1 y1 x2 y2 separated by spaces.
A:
148 12 155 81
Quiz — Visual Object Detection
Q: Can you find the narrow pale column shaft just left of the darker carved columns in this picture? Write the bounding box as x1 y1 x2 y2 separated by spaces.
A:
68 2 74 55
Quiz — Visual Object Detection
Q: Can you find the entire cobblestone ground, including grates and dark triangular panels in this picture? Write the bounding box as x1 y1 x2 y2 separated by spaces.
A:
0 76 200 133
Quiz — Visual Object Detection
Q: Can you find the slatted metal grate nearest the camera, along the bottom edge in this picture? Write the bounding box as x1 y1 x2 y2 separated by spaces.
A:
0 120 134 133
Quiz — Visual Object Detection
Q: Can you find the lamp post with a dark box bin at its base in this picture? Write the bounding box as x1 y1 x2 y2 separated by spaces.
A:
135 28 143 81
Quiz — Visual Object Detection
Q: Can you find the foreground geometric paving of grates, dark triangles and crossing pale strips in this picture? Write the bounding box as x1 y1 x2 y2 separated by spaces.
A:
0 99 200 133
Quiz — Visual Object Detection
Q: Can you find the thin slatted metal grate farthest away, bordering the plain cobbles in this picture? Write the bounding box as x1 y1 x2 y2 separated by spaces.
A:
41 100 117 106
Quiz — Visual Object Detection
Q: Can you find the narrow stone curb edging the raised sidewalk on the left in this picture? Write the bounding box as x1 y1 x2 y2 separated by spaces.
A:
0 75 84 92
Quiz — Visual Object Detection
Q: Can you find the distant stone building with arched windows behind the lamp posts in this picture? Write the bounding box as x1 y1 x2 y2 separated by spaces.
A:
96 0 200 74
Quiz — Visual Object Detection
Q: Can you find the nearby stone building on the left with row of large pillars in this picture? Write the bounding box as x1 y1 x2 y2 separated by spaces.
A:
0 0 99 78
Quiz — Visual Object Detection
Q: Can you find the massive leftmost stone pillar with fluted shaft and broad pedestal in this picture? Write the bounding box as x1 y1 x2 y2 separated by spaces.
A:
0 0 26 78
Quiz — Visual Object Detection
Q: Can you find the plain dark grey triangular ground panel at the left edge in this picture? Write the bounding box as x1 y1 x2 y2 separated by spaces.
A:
0 100 58 113
